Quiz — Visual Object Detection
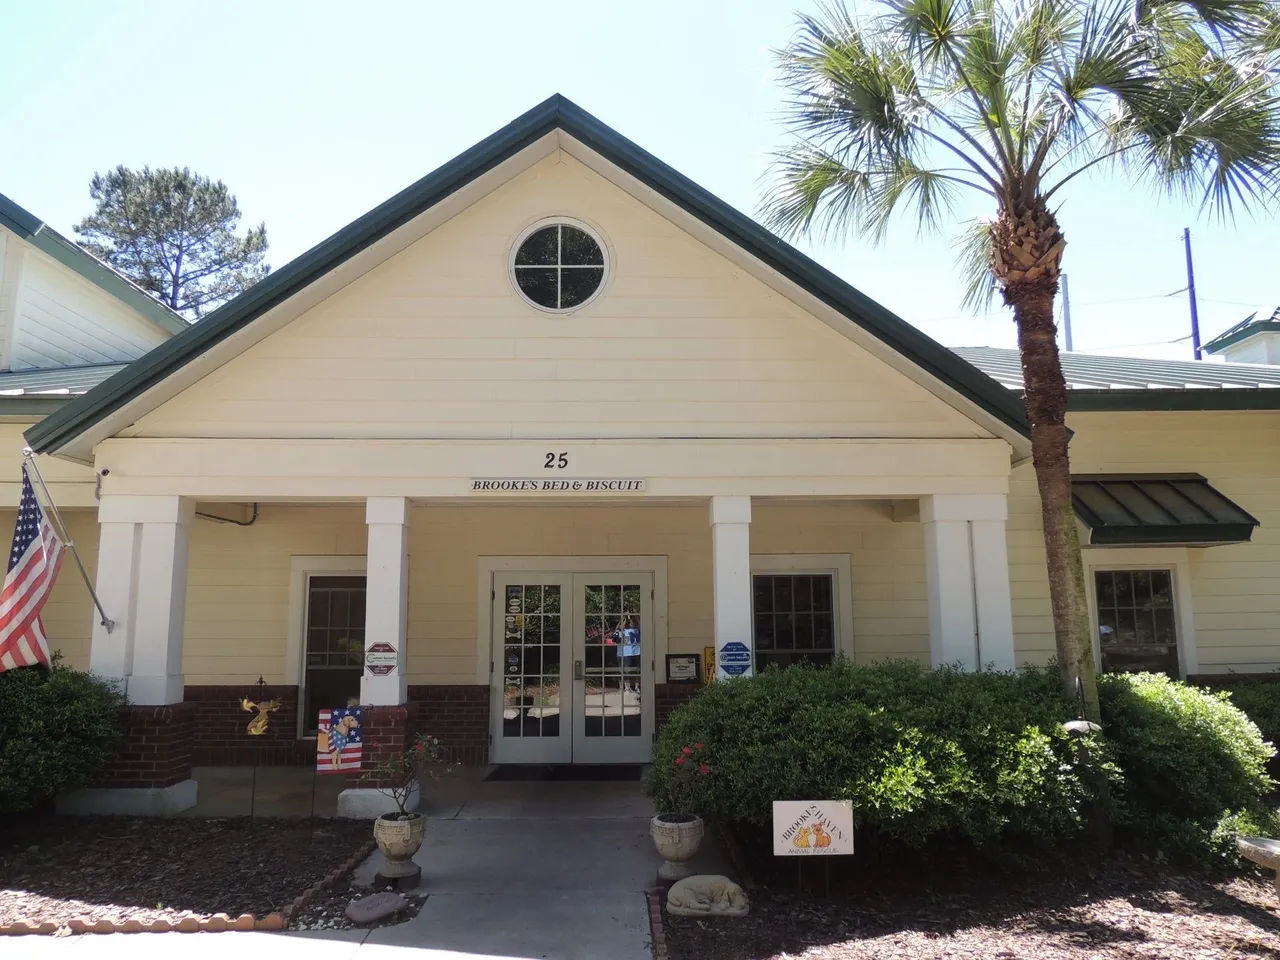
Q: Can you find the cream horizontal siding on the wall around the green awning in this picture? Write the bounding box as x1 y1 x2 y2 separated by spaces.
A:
1009 411 1280 673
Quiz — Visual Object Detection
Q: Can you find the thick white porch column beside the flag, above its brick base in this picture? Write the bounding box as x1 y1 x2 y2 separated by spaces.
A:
90 497 195 704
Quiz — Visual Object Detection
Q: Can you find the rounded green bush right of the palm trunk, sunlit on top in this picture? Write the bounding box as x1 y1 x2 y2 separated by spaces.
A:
1098 673 1275 854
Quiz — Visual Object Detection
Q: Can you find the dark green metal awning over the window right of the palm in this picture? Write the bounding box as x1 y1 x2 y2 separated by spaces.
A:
1071 474 1258 547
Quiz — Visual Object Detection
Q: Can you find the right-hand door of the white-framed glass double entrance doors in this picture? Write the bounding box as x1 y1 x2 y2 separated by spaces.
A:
572 573 653 763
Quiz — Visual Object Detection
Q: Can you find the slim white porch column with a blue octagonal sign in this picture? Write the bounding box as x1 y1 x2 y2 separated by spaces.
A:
710 497 754 680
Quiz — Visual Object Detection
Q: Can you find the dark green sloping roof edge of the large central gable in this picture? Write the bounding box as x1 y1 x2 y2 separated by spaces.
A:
27 95 1030 452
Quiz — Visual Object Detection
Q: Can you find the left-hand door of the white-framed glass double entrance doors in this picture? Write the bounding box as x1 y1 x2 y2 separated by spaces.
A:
493 573 572 763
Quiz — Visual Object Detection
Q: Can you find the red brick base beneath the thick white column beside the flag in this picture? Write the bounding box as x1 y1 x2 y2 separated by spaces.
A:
97 703 196 787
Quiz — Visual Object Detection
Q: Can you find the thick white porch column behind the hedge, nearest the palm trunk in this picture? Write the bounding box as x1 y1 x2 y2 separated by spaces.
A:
920 494 1015 669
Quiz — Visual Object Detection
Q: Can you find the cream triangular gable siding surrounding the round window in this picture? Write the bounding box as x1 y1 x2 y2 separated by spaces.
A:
129 156 983 438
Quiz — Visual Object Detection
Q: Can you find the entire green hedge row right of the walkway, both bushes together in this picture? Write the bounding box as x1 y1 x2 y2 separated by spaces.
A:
646 662 1275 852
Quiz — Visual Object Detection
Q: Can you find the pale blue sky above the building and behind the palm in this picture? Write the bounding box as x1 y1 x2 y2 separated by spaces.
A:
0 0 1280 358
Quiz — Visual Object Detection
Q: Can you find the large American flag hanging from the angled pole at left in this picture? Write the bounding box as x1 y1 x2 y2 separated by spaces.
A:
0 465 63 671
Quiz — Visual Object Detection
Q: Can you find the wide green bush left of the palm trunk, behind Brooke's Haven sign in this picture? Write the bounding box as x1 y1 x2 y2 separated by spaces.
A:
646 662 1103 845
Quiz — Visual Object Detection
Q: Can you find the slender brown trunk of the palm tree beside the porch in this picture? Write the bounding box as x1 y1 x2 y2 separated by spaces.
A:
1005 276 1101 722
